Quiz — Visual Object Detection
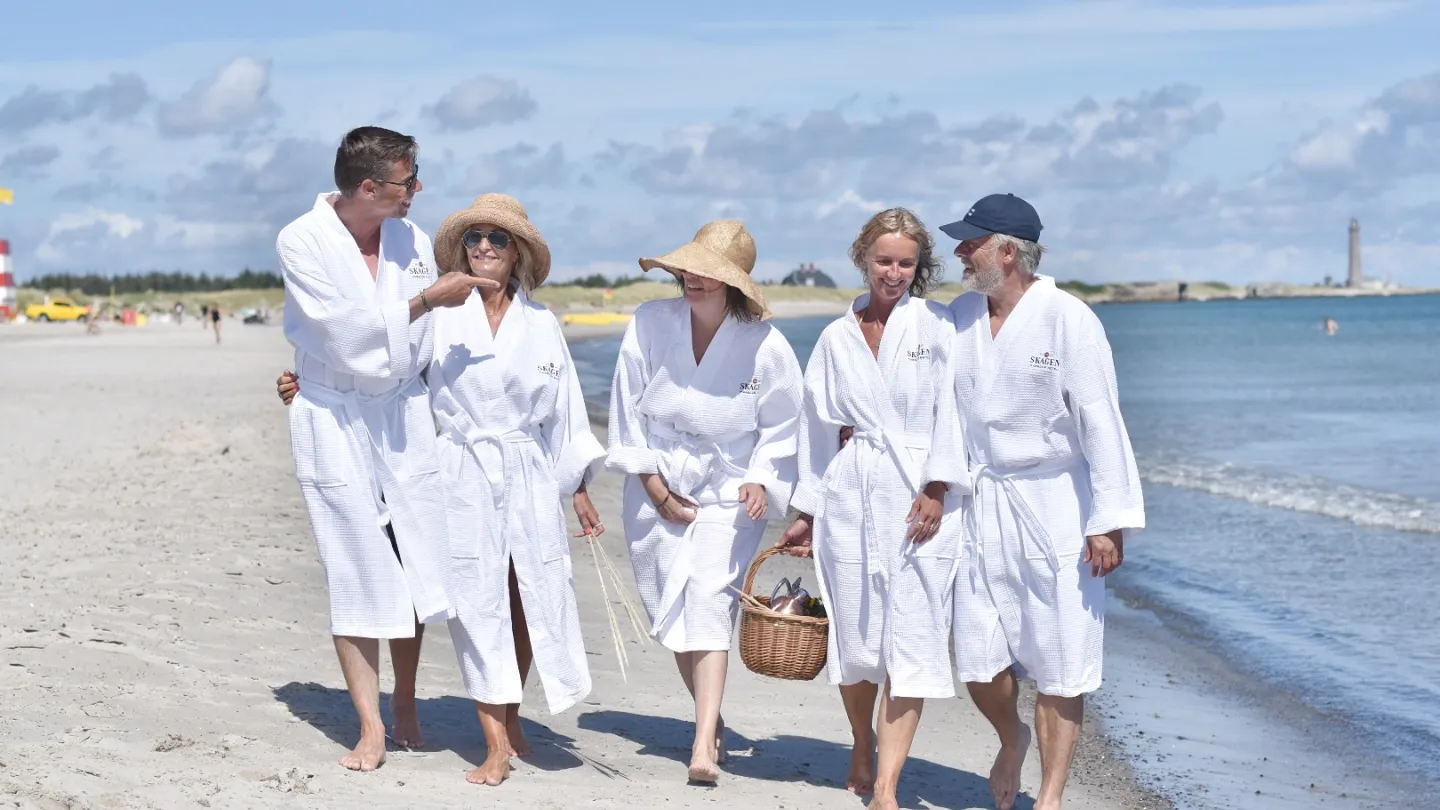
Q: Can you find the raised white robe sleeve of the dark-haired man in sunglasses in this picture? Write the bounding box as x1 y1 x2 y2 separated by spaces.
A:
275 231 413 378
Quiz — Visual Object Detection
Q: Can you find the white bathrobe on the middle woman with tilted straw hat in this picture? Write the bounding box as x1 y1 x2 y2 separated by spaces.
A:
608 298 801 653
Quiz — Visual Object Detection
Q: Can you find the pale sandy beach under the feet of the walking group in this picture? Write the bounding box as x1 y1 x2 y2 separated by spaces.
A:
0 323 1168 810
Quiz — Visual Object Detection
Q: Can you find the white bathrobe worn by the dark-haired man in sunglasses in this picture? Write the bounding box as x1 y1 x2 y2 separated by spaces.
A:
276 195 449 638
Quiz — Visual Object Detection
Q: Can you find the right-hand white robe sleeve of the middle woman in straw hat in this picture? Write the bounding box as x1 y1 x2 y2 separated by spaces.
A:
743 331 804 516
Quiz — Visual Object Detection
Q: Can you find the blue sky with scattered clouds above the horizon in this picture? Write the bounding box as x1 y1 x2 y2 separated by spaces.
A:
0 0 1440 285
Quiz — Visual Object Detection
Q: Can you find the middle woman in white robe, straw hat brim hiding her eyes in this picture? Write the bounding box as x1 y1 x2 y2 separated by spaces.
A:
608 219 801 783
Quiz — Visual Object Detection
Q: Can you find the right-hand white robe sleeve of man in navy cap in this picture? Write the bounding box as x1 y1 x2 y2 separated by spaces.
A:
1064 316 1145 536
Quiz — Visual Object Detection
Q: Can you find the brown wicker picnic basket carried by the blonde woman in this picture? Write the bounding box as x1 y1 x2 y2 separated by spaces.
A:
740 548 829 680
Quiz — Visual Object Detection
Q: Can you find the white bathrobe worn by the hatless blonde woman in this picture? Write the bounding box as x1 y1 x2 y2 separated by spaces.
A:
791 294 965 698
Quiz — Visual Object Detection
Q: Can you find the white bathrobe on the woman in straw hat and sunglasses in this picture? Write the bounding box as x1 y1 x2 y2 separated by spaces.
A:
429 285 605 712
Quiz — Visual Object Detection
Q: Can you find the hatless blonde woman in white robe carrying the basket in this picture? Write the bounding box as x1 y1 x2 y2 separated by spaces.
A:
778 208 963 809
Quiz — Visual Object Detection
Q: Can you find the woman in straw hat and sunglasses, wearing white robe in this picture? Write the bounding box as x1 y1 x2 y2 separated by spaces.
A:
276 195 605 785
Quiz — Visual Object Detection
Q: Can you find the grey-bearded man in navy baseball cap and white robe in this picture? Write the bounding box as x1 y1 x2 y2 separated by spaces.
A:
933 195 1145 810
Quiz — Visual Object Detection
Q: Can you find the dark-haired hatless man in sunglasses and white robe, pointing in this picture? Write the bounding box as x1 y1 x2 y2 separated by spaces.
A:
276 127 498 771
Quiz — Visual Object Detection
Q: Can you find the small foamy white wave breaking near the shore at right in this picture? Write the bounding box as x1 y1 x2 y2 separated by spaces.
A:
1140 457 1440 535
